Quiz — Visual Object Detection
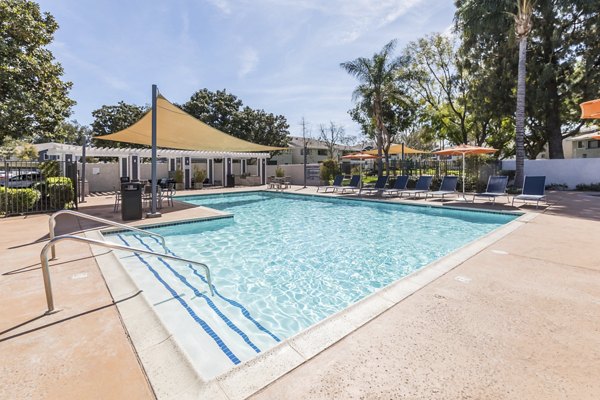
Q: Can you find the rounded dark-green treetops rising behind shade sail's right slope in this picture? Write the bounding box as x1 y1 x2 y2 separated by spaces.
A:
180 89 289 147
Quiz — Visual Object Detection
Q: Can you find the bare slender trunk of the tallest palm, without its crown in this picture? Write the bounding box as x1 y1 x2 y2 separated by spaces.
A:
515 36 527 188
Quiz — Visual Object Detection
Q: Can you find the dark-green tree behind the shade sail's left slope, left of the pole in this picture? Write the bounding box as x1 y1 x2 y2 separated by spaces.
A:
92 101 148 147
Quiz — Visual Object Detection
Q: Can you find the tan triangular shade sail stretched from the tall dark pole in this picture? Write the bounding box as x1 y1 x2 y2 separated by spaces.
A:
96 95 286 152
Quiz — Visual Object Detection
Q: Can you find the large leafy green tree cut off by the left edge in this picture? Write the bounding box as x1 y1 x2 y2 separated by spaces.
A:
0 0 75 142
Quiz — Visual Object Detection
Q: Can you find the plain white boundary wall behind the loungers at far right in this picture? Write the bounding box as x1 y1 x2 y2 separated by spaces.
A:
502 158 600 189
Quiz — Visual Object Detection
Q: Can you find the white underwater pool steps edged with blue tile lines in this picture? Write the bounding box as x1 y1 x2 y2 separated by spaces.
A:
110 234 279 375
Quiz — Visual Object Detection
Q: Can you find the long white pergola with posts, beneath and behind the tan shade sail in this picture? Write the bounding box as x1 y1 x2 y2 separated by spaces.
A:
36 143 269 189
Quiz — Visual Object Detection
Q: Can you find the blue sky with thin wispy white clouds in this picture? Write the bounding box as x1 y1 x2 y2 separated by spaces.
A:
39 0 454 136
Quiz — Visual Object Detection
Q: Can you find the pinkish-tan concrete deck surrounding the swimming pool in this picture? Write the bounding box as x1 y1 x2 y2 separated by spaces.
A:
0 187 600 399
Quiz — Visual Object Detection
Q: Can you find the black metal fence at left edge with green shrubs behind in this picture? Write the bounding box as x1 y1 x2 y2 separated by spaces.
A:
0 160 77 217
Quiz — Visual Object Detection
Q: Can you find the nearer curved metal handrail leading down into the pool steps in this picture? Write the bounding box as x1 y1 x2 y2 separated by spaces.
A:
40 235 215 313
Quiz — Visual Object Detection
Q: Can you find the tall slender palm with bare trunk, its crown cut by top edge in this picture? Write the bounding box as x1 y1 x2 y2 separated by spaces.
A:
513 0 535 187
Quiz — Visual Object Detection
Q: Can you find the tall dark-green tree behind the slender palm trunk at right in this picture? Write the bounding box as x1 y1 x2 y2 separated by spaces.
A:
455 0 600 163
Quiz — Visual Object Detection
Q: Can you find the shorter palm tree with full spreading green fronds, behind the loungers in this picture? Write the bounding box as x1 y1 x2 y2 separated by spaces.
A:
340 40 399 176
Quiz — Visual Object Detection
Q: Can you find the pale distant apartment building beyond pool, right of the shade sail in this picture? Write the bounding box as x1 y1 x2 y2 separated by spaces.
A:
269 136 362 165
